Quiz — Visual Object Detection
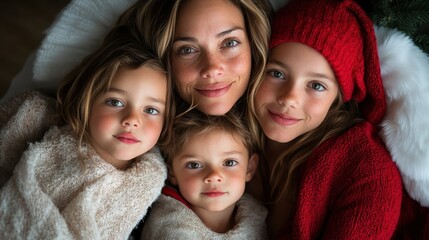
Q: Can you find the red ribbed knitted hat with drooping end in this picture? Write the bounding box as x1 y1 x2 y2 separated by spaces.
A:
270 0 386 124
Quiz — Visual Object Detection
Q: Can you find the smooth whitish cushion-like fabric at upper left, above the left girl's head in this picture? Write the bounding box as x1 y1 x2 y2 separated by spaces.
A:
33 0 137 89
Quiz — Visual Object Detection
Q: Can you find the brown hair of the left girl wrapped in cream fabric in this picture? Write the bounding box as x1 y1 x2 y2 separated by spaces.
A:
57 26 175 145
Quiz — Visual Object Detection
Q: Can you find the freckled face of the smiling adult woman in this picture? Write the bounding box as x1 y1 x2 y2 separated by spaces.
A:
171 0 251 115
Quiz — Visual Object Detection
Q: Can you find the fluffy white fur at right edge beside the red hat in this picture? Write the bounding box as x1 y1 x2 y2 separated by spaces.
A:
375 27 429 207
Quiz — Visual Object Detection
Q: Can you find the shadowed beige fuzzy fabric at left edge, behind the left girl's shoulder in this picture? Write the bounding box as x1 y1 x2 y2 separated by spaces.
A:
0 91 63 188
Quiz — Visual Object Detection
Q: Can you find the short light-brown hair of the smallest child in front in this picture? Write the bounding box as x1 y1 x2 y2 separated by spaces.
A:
160 108 258 166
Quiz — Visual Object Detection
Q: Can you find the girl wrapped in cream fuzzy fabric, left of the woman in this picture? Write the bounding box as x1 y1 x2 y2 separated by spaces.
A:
0 24 172 239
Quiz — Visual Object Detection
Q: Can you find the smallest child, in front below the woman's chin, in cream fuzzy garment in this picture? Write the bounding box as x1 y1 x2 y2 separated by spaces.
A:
142 110 267 239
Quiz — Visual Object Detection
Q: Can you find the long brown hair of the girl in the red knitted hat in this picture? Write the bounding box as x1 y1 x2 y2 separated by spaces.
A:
248 84 363 203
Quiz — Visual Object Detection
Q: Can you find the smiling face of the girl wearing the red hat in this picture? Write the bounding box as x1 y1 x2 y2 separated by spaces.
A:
255 43 339 143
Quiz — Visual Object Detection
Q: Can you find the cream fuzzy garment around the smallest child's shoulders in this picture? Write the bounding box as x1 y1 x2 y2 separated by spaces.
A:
141 194 268 240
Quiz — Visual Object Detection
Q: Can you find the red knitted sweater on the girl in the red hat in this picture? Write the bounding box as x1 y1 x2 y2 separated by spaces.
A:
279 122 402 239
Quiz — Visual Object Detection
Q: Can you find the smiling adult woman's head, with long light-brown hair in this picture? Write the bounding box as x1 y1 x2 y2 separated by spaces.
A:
119 0 270 115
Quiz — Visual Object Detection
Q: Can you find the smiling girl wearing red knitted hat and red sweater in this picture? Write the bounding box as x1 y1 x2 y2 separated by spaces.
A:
246 0 402 239
